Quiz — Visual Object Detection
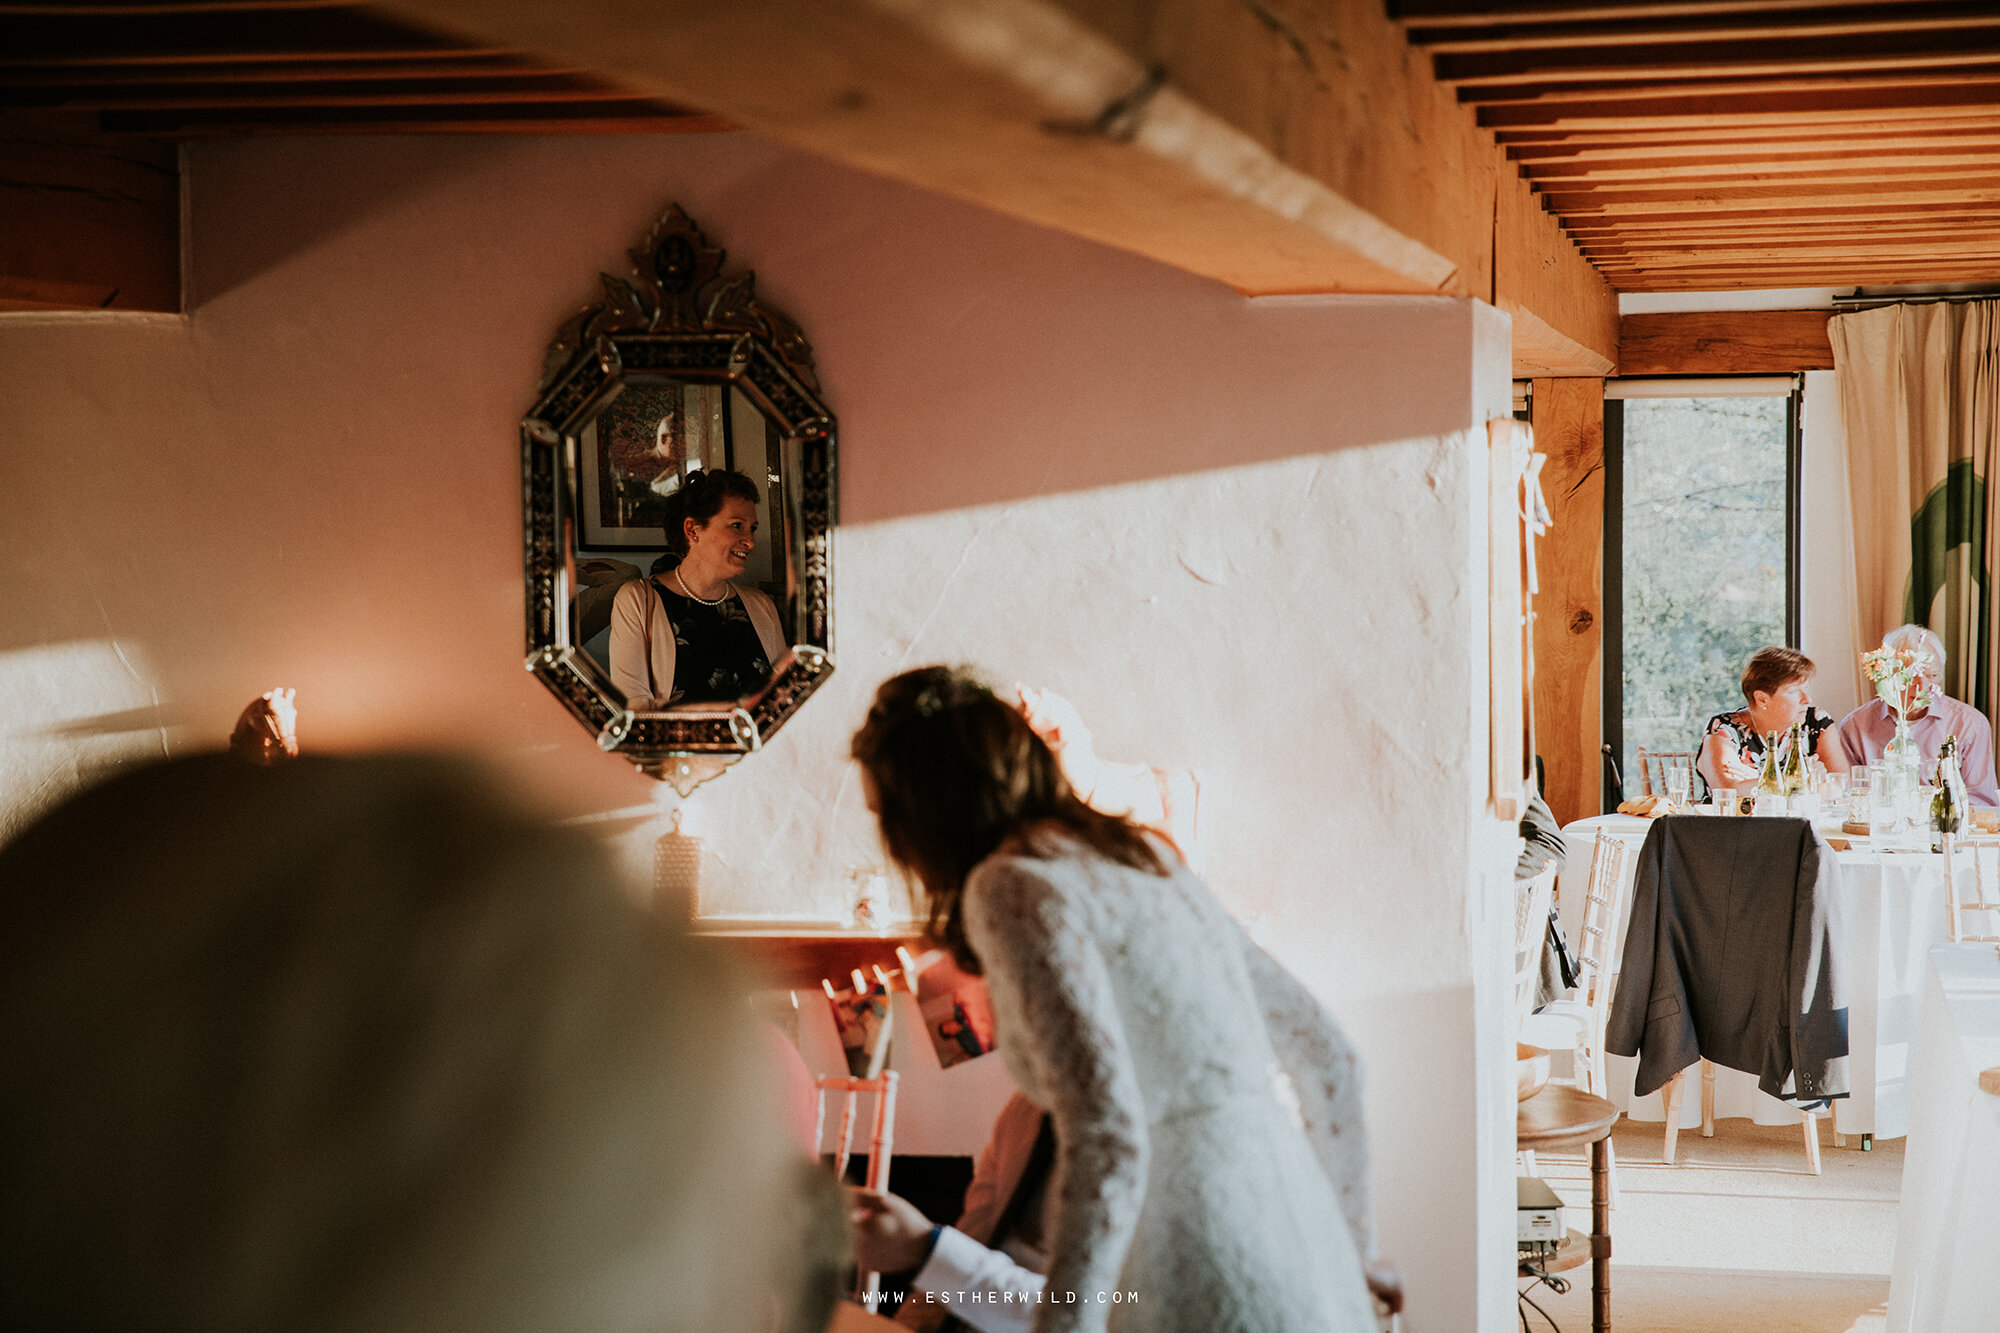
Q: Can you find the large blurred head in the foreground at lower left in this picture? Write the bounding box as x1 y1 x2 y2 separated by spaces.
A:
0 755 816 1333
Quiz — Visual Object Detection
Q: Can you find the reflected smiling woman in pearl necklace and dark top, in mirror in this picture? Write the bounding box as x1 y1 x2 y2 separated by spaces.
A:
612 470 784 713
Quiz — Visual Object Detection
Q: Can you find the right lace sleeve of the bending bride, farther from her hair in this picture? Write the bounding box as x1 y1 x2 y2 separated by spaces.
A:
1236 927 1376 1261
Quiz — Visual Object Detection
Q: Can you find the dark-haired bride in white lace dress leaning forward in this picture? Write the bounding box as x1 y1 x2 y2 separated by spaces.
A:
854 667 1378 1333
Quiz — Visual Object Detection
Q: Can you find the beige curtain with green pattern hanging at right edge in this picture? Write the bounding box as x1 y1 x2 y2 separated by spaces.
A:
1828 300 2000 717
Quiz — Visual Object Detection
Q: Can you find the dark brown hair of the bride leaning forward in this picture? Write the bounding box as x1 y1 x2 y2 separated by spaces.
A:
852 667 1168 973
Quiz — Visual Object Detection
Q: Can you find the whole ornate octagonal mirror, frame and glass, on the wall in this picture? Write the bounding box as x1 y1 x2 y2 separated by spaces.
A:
520 204 834 793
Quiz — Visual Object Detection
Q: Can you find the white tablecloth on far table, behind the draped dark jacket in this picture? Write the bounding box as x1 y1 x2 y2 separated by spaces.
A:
1558 815 1944 1139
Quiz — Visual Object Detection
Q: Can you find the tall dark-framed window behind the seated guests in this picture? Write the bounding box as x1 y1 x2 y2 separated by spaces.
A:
1604 378 1800 797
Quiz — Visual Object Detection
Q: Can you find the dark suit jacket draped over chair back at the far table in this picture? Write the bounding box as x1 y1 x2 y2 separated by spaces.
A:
1604 817 1848 1101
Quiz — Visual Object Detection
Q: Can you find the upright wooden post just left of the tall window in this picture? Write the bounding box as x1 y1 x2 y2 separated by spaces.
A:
1532 378 1604 825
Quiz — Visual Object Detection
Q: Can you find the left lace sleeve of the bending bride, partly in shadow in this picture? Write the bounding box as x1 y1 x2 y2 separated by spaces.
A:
966 859 1148 1333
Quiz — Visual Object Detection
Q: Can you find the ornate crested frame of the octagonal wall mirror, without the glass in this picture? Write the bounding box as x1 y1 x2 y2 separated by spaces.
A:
520 204 834 793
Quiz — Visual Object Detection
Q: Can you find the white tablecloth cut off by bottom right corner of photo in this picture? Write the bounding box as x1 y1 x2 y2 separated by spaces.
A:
1888 945 2000 1333
